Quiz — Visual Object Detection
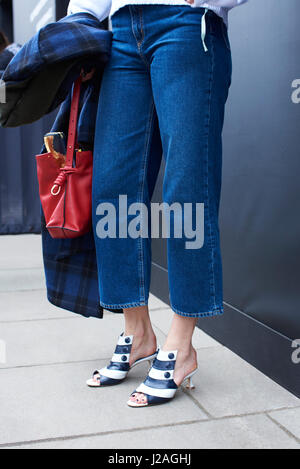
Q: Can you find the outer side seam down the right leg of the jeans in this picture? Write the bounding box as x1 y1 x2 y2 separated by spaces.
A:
206 27 216 308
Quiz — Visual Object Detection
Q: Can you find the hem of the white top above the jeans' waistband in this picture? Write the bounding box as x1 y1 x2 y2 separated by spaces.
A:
68 0 248 24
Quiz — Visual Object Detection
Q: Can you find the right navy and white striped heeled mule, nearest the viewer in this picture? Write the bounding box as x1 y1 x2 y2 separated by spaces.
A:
127 349 198 407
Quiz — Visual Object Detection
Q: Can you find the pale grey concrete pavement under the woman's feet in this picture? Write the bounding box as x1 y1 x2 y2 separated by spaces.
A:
0 235 300 449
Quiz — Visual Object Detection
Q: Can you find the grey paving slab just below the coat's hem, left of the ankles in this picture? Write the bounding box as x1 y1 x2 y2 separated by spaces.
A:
0 314 164 369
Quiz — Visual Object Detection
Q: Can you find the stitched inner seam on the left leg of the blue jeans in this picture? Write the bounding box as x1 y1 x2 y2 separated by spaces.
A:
137 98 154 301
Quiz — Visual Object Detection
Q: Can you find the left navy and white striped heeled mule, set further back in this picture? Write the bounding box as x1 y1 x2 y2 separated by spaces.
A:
86 333 158 388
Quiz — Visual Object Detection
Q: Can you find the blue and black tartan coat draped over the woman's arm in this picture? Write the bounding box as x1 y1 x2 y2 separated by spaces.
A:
0 13 162 318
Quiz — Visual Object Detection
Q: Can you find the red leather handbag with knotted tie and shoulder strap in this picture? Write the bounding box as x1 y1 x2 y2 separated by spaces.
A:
36 76 93 238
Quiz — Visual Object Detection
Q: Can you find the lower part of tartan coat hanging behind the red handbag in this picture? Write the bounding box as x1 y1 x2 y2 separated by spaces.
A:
40 83 122 319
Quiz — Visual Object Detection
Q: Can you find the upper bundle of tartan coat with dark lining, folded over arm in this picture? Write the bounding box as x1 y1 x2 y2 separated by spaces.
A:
0 13 112 128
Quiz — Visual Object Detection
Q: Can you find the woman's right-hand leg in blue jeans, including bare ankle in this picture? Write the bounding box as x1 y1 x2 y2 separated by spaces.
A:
126 7 231 404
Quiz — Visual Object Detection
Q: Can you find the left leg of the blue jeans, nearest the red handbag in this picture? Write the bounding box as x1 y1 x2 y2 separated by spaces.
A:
93 7 162 309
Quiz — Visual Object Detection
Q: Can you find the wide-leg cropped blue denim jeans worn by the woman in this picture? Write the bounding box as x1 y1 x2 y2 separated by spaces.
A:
93 5 232 317
